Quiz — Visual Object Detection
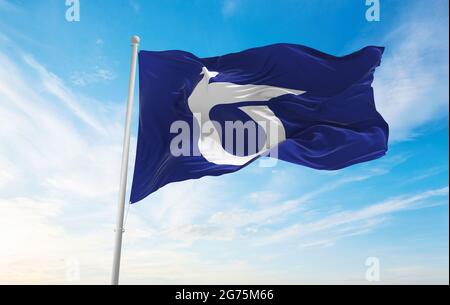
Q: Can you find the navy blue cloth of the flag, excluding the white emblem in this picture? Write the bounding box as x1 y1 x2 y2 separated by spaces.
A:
131 44 389 203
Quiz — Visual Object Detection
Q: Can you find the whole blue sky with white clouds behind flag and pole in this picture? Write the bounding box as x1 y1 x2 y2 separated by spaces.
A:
0 0 449 284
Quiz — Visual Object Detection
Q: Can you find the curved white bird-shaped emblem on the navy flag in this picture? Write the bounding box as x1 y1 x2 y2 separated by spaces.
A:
188 67 305 166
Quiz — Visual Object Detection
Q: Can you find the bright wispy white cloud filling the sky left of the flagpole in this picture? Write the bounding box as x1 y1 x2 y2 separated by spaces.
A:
0 40 126 283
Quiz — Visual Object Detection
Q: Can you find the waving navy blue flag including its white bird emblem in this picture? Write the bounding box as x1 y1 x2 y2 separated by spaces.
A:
131 44 389 203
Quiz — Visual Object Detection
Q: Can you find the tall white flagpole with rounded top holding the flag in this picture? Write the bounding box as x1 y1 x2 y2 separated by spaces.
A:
111 36 140 285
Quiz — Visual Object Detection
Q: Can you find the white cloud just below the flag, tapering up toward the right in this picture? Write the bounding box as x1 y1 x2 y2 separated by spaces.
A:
141 156 406 245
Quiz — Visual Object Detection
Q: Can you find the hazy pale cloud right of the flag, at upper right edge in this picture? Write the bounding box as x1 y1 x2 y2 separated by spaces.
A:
374 2 449 141
